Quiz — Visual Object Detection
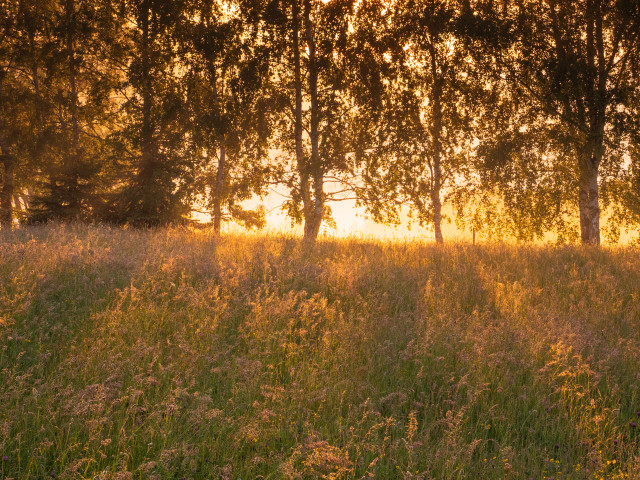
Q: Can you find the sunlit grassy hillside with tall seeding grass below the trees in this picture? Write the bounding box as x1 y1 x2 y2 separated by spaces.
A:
0 226 640 480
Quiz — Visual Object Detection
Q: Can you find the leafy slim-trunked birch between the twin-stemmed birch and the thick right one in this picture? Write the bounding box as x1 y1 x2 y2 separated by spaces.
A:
356 1 481 240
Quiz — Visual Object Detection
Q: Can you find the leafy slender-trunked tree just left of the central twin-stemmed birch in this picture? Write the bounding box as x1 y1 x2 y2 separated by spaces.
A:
178 2 274 228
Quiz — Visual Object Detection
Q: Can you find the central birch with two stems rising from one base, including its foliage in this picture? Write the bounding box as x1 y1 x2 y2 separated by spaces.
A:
261 0 356 242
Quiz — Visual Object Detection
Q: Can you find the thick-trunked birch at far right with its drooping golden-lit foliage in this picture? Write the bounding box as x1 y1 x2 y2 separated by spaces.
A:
476 0 640 243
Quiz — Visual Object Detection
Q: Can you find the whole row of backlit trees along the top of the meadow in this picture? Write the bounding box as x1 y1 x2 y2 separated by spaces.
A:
0 0 640 244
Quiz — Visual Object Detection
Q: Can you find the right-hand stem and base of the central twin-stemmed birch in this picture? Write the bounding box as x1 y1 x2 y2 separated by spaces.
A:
304 0 324 242
